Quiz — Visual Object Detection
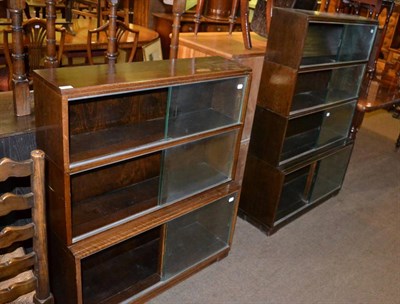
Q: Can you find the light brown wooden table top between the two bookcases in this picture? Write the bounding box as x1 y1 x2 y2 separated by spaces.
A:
179 32 267 59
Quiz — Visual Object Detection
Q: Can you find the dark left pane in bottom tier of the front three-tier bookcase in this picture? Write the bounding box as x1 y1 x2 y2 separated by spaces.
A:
81 227 161 304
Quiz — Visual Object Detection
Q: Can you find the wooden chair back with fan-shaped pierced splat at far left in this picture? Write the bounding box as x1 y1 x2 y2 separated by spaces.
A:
3 18 65 87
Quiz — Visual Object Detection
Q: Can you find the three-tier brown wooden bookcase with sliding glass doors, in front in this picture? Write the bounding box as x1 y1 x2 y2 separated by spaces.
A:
34 57 251 303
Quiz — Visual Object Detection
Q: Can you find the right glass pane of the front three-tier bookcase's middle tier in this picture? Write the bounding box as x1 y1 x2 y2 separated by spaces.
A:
160 131 237 204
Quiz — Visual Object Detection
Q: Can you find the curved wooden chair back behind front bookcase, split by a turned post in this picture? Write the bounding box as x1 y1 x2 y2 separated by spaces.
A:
87 20 139 64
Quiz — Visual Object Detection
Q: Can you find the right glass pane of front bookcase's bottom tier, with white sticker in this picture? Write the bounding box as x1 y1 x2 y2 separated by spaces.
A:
162 193 237 280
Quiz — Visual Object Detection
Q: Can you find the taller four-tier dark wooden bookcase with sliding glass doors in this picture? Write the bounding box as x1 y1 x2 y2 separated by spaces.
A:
239 8 377 234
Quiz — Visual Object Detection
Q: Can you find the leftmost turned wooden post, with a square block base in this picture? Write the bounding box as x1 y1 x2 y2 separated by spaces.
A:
8 0 31 116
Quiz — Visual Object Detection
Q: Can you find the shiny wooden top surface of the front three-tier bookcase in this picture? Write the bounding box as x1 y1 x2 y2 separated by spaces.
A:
34 57 251 97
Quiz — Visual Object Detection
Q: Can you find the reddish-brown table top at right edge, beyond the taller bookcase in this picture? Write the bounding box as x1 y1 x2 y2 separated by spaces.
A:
357 74 400 112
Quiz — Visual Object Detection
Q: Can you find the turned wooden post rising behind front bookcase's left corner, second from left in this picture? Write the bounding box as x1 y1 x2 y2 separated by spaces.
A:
44 0 60 68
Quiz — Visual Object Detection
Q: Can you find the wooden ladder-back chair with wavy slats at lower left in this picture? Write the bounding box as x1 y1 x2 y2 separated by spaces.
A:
0 150 54 304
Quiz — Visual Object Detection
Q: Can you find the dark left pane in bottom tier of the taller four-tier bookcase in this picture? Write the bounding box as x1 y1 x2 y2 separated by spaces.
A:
275 166 310 221
